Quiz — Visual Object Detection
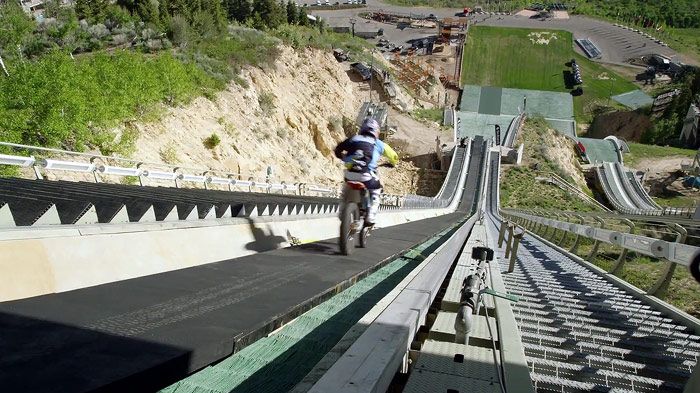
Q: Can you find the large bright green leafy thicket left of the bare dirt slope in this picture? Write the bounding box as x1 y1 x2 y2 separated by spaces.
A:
0 51 211 150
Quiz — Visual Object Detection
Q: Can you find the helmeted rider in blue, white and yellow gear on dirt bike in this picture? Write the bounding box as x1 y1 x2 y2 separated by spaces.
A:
335 118 399 227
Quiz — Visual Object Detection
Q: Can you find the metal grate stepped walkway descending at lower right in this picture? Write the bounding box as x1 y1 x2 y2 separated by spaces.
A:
501 236 700 392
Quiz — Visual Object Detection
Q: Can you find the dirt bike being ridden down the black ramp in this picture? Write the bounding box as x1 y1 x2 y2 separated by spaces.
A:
338 164 394 255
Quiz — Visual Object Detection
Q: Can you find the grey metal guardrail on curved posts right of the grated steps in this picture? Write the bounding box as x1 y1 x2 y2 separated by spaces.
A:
501 211 700 295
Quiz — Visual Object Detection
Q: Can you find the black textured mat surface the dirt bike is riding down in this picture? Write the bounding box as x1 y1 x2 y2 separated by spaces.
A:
0 213 465 392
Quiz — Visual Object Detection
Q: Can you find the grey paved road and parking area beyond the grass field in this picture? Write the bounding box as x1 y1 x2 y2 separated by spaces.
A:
309 0 691 63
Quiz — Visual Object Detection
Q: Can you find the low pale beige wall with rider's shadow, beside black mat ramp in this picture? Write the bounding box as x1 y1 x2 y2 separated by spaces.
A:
0 209 450 301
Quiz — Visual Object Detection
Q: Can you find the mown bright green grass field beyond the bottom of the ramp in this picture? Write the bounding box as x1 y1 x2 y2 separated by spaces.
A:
462 26 636 122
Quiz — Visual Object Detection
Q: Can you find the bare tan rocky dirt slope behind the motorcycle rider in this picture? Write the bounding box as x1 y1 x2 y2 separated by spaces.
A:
123 48 426 193
